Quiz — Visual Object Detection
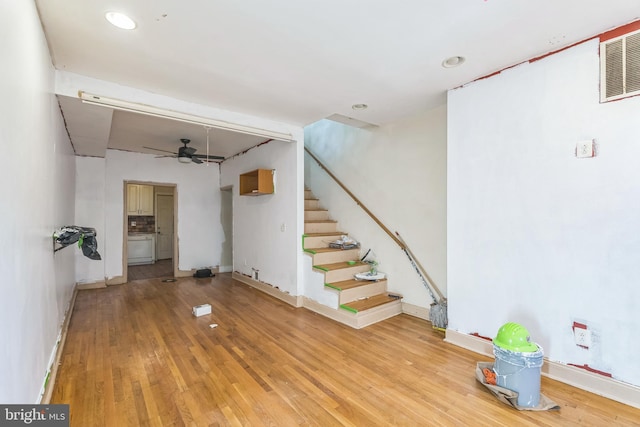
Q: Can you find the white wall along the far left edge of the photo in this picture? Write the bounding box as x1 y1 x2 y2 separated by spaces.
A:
0 2 77 403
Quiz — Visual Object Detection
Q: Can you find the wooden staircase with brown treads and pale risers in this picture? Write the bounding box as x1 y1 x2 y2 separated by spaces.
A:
302 189 402 329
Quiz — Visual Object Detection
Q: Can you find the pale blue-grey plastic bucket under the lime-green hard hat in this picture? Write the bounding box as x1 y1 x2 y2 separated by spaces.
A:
493 344 543 408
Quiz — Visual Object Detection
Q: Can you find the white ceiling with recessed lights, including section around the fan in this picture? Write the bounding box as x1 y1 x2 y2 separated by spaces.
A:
35 0 640 160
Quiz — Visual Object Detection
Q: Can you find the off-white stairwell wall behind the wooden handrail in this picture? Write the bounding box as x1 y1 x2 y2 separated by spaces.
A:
305 106 447 308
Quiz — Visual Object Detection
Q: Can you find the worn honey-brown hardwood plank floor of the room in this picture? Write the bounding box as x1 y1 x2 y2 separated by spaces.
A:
51 274 640 426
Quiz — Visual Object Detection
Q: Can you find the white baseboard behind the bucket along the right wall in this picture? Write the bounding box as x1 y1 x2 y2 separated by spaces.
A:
445 329 640 408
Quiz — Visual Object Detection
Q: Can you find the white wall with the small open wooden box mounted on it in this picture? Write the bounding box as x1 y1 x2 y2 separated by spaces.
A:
221 139 304 295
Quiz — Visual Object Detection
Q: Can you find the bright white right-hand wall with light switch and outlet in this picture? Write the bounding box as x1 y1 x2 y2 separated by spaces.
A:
447 40 640 385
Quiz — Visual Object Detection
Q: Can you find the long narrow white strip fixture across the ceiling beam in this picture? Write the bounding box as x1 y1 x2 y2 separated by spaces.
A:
78 91 293 142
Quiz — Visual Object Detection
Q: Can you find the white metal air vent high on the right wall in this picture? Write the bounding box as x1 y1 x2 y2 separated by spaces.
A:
600 31 640 102
